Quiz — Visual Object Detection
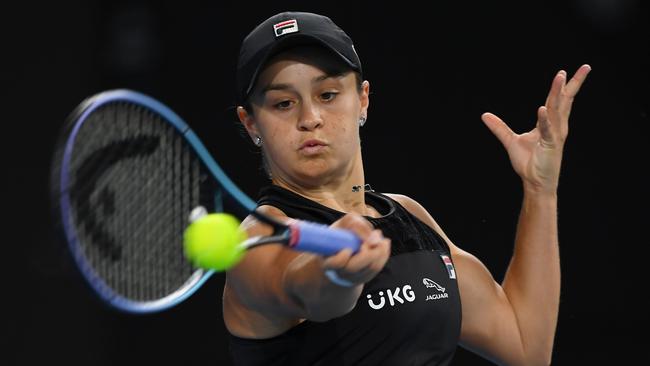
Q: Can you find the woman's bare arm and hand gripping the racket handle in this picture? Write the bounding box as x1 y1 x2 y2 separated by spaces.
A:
223 206 390 338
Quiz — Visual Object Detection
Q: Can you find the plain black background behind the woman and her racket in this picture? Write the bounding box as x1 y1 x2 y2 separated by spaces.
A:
0 0 650 365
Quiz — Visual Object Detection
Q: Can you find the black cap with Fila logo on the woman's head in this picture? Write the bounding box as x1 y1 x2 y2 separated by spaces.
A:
237 12 361 104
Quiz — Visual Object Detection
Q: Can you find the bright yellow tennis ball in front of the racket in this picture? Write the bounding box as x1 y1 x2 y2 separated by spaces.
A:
183 213 246 271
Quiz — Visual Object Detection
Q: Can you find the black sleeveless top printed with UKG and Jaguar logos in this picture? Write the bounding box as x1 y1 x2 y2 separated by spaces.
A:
230 186 461 366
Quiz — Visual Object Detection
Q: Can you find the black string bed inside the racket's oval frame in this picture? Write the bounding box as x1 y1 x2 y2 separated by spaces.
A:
71 103 205 301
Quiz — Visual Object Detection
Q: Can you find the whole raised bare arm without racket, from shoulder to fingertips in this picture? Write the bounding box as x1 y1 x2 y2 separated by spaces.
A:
400 65 591 365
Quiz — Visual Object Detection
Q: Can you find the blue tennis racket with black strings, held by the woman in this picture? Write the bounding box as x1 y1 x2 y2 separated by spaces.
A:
51 89 360 313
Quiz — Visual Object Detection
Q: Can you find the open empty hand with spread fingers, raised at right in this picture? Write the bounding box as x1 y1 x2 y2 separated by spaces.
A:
481 65 591 193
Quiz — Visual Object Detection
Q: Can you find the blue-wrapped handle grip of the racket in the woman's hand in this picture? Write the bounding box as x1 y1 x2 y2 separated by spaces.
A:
289 221 361 255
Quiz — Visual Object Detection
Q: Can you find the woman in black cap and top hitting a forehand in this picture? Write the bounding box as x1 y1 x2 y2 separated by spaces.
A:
223 12 591 366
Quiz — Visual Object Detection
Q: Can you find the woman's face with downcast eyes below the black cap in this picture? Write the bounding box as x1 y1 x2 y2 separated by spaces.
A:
240 50 369 187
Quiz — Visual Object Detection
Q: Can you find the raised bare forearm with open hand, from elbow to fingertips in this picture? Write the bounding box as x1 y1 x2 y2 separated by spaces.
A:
470 65 591 364
